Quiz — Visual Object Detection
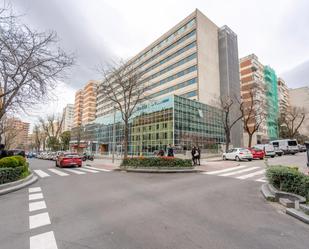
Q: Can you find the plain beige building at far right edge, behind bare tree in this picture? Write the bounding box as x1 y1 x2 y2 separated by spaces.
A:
289 86 309 136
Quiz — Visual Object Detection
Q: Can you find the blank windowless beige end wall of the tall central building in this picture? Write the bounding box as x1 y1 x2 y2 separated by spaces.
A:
196 10 220 107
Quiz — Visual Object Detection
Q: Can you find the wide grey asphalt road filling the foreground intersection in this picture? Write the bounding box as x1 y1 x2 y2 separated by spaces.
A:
0 159 309 249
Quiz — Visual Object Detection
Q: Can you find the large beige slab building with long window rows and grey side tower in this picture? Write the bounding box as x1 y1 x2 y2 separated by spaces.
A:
96 9 242 146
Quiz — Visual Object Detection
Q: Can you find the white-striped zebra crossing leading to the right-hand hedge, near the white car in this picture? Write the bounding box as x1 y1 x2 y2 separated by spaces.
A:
202 165 266 182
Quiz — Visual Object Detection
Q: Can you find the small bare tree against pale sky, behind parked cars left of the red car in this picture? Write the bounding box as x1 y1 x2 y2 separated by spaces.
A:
39 114 64 151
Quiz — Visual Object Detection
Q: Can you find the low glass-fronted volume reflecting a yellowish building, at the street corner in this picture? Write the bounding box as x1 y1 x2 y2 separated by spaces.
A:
71 95 225 155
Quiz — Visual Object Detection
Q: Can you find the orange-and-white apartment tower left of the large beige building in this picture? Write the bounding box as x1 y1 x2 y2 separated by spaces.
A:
73 80 98 127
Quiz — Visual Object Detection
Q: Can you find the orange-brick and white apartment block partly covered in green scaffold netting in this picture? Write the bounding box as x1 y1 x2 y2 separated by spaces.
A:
240 54 279 145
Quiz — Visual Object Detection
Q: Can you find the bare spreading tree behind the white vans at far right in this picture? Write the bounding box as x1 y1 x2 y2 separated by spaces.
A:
279 106 306 138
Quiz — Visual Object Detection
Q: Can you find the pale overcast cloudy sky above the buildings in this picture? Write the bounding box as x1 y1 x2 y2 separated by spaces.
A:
6 0 309 127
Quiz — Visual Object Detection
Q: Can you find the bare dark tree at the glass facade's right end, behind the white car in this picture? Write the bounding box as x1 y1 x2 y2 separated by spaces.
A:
220 96 243 151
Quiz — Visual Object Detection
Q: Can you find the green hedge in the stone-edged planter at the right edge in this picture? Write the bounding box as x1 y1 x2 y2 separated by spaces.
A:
266 166 309 201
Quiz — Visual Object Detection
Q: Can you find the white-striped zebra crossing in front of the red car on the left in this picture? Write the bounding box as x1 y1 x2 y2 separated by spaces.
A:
33 166 110 178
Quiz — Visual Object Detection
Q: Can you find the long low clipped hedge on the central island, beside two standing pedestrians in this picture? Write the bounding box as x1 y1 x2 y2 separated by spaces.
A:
121 157 193 168
